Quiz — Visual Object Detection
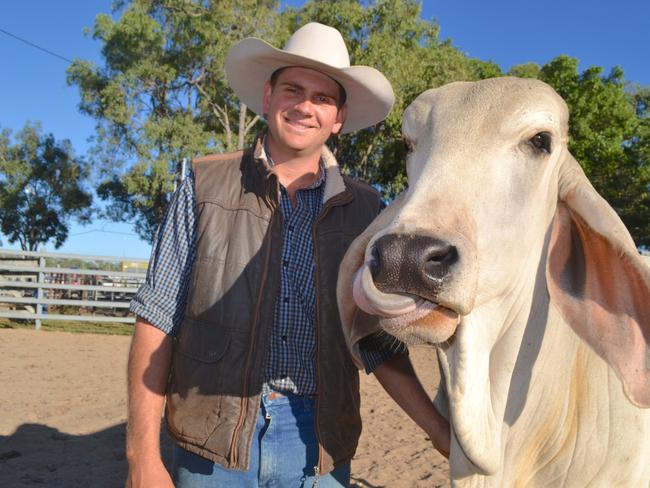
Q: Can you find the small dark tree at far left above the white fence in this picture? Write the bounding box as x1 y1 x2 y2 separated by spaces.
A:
0 123 92 251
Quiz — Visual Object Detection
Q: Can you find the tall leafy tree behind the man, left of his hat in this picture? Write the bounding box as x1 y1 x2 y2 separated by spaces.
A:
68 0 291 242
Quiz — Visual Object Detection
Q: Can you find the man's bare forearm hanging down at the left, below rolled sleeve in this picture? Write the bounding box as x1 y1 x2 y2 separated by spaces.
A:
126 317 174 488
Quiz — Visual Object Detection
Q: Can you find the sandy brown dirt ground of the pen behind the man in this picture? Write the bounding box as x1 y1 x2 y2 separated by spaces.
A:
0 329 449 488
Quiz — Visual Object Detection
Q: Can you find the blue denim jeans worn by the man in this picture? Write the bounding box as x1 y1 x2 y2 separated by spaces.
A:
173 392 350 488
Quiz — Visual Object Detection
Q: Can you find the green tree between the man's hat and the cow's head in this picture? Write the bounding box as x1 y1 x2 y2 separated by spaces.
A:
293 0 501 198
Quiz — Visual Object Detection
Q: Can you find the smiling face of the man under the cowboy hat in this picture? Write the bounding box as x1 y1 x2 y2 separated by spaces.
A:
263 68 346 159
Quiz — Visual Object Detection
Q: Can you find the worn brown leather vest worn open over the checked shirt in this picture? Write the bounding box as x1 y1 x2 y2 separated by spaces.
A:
167 143 380 473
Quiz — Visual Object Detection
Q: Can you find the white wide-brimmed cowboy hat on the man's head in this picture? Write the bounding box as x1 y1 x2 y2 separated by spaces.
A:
225 22 395 134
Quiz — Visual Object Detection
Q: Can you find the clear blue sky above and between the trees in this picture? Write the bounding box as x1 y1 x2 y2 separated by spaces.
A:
0 0 650 257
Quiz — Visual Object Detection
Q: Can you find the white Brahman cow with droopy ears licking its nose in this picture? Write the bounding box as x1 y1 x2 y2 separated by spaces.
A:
338 78 650 488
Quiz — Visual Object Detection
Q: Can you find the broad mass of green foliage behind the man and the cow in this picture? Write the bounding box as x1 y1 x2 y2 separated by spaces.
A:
68 0 650 245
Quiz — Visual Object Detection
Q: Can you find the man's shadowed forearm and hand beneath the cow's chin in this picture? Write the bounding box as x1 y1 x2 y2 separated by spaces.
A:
373 354 450 458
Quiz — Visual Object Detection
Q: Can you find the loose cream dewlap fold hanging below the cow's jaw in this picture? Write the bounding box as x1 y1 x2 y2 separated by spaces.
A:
441 241 548 478
